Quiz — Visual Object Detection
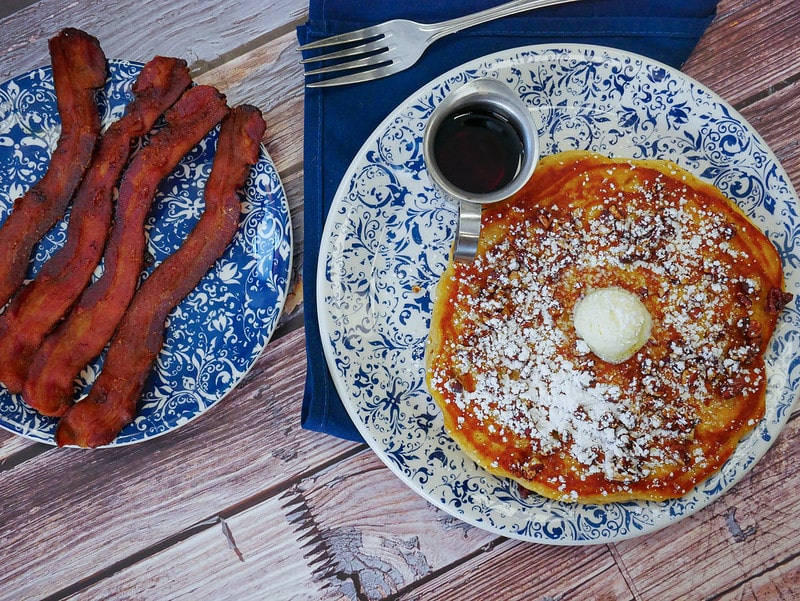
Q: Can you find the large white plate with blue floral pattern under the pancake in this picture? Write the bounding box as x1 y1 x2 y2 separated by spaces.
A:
318 45 800 544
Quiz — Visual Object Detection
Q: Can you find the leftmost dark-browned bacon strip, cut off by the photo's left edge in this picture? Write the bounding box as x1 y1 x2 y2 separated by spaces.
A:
0 29 106 307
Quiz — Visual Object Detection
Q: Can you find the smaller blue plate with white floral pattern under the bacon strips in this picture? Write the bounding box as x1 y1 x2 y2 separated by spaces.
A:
0 60 292 446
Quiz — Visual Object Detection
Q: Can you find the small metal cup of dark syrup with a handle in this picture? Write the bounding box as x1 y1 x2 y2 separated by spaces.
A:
423 78 539 262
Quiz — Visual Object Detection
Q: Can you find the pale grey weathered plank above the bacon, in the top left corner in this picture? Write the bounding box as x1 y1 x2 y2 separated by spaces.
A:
0 0 308 81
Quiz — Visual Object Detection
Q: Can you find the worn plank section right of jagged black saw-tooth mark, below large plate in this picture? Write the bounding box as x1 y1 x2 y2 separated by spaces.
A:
284 450 497 599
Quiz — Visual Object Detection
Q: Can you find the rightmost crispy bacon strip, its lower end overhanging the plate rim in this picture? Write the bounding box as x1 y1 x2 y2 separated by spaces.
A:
56 105 264 447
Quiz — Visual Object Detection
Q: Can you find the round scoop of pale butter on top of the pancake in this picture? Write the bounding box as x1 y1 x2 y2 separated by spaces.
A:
572 287 653 363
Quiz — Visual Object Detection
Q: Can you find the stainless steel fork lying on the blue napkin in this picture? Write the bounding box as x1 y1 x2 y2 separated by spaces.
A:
300 0 577 88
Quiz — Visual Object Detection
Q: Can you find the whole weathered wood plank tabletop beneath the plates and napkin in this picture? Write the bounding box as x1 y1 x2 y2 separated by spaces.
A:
0 0 800 600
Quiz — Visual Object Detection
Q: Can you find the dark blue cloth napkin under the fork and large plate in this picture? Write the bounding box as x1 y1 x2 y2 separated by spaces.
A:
297 0 717 441
